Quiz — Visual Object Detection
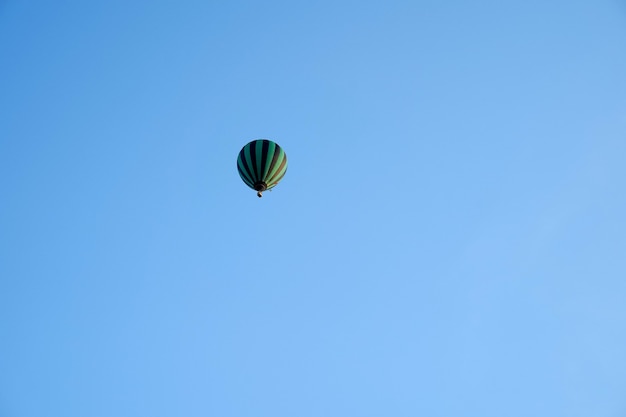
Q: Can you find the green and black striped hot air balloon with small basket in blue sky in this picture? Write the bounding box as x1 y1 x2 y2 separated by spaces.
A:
237 139 287 197
